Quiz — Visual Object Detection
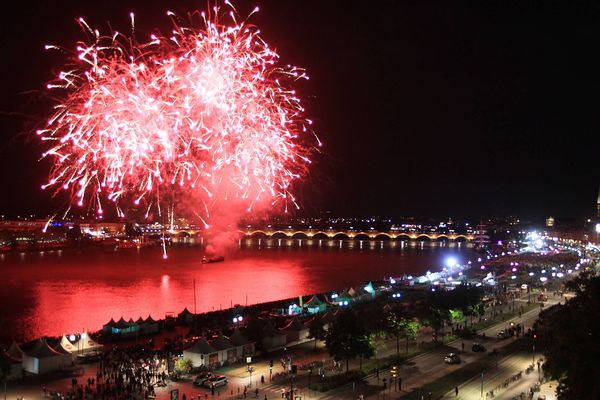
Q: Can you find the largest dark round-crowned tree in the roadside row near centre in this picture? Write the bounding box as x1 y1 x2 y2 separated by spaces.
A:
325 309 374 372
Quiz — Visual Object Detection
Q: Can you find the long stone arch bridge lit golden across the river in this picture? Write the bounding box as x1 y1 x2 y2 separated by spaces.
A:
174 229 477 242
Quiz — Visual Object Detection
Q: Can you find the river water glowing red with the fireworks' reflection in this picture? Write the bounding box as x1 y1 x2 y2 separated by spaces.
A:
0 239 476 343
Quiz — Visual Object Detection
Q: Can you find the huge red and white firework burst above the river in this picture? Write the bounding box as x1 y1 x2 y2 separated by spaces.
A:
38 3 321 226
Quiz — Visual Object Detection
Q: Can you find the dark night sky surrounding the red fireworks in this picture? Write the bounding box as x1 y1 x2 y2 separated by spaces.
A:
0 0 600 217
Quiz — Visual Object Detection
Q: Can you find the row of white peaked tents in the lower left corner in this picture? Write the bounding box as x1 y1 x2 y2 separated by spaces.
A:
0 334 102 379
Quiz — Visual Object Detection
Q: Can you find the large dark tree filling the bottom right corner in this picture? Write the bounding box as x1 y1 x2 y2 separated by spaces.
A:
532 277 600 400
